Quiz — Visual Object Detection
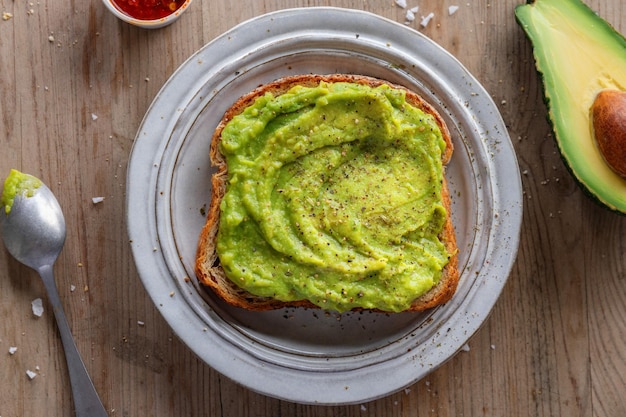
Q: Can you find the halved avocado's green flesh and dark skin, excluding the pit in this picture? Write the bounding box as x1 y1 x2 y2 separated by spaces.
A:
515 0 626 213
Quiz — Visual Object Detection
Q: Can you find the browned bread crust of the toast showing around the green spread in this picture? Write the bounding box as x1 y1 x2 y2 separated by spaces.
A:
196 74 459 311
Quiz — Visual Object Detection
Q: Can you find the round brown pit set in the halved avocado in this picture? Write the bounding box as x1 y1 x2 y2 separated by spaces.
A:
591 90 626 178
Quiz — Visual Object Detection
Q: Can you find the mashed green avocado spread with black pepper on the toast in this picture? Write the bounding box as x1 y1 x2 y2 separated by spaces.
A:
217 79 449 312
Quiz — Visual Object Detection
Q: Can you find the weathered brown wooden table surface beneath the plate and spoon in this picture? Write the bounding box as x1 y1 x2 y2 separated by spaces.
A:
0 0 626 417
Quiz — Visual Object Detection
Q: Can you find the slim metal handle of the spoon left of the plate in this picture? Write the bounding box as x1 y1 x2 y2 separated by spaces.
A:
38 265 107 417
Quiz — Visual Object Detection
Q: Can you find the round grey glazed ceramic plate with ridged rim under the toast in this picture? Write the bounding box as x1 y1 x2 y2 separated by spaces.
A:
127 8 522 404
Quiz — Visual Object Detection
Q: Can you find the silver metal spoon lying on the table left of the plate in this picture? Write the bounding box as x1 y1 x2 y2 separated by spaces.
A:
0 172 107 417
